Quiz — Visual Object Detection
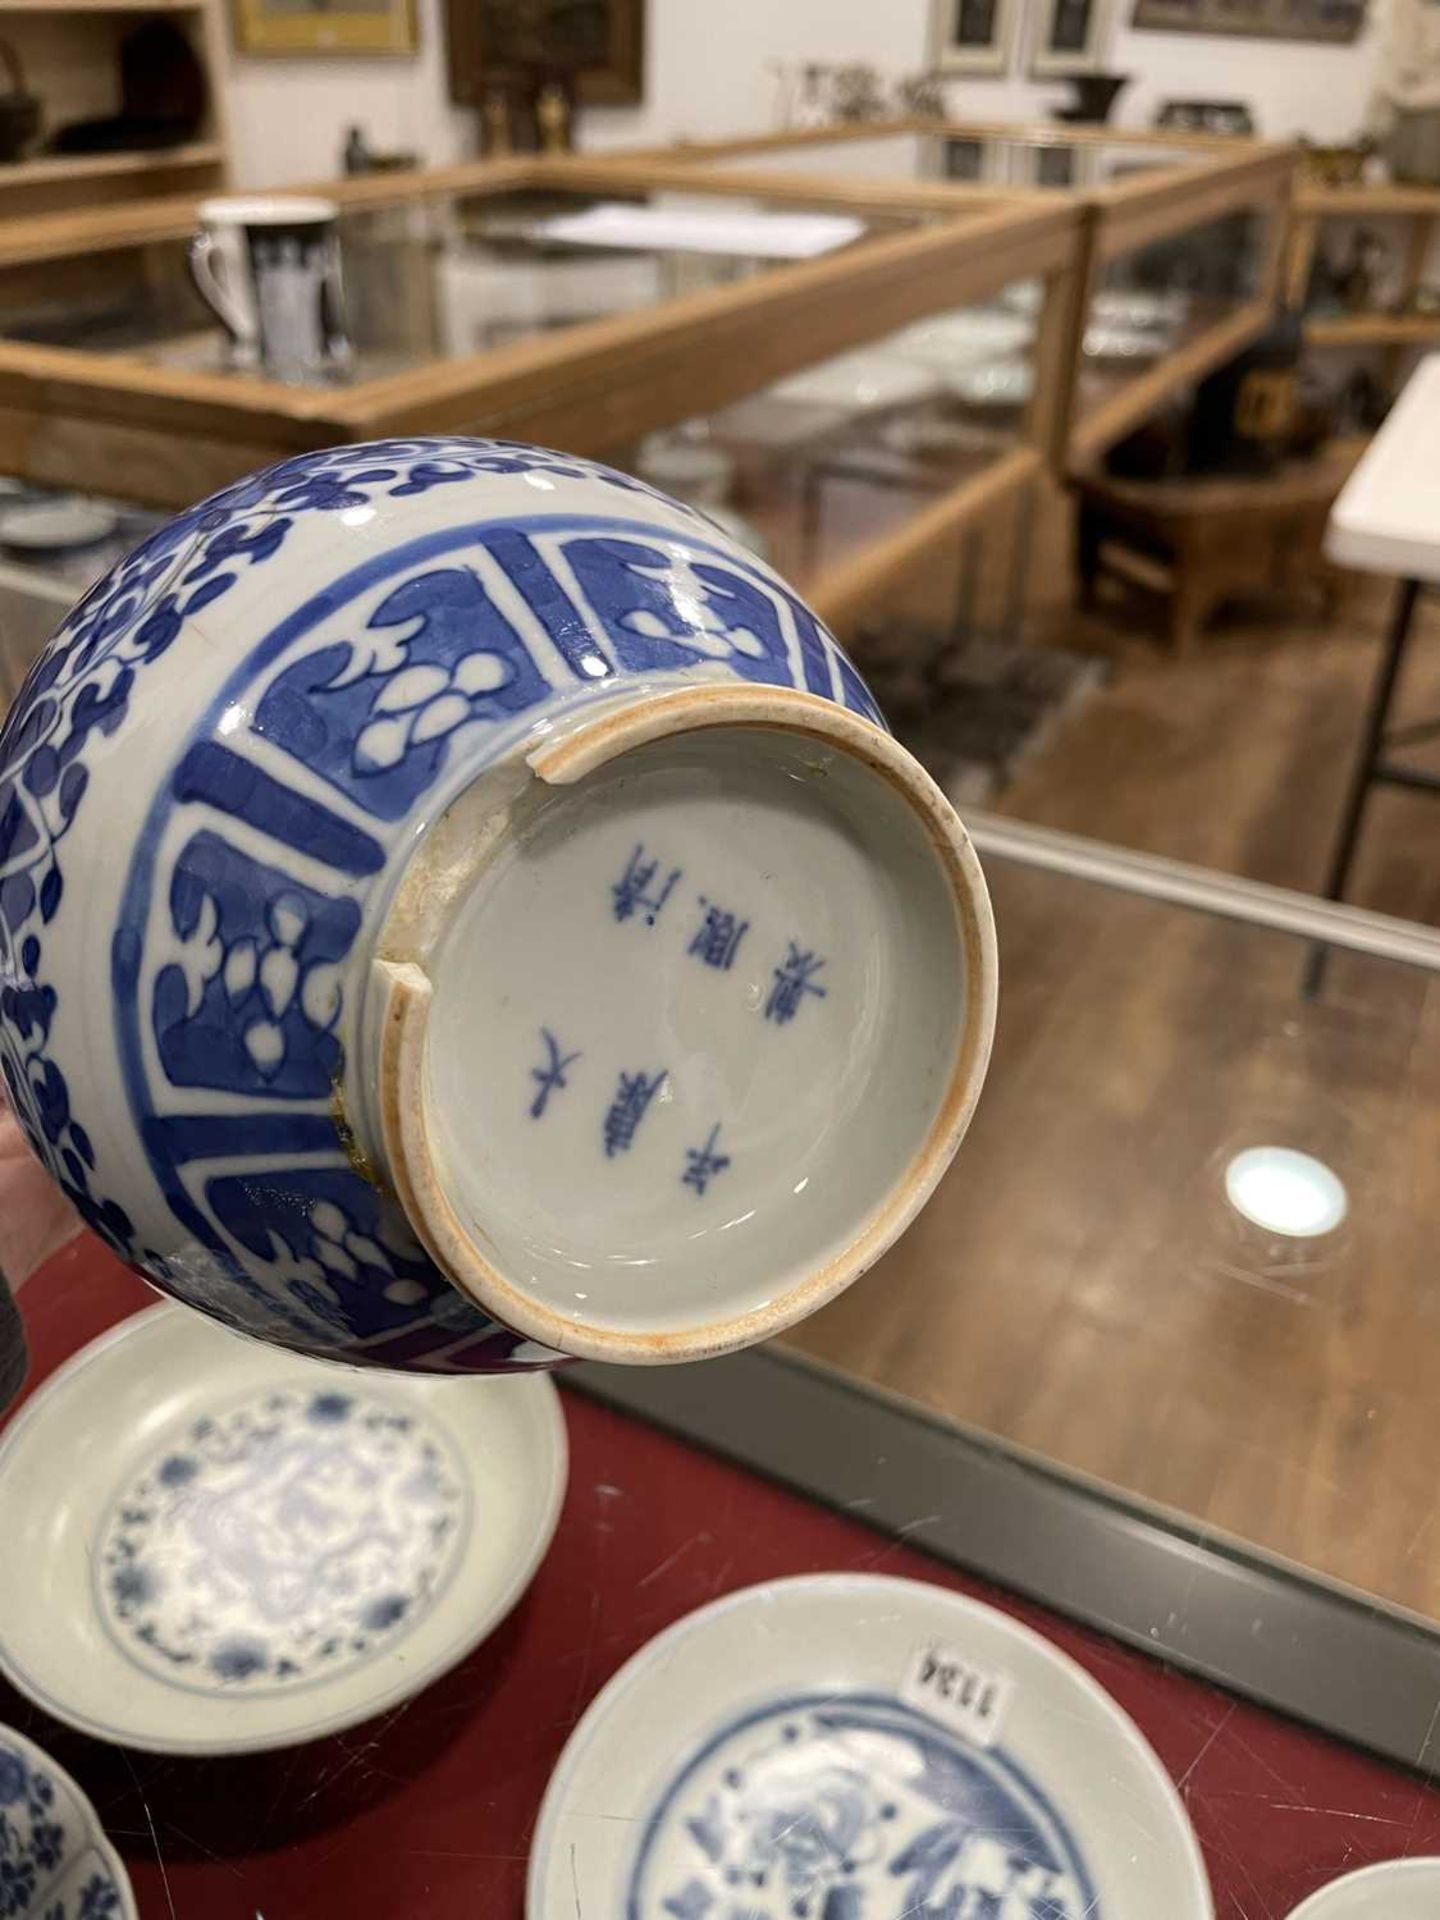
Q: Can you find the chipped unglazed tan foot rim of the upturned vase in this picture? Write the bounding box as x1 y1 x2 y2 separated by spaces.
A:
372 684 996 1365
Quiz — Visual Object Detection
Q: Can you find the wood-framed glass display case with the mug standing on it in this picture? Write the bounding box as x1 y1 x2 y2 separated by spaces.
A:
0 161 1081 624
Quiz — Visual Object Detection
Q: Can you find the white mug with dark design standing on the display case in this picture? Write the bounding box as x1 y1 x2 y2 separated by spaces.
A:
190 194 349 378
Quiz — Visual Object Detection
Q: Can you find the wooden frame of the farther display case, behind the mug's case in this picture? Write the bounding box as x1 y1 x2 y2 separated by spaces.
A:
591 117 1298 472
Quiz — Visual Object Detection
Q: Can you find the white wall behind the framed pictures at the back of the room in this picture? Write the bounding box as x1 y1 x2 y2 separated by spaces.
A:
230 0 1384 186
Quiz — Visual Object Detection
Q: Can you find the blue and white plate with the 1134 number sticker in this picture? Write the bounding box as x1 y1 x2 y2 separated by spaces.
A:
526 1574 1213 1920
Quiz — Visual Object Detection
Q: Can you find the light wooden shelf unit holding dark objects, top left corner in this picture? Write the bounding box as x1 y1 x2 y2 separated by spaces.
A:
0 0 228 221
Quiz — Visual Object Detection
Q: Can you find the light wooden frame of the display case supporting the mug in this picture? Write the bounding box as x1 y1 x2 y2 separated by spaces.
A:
0 157 1083 630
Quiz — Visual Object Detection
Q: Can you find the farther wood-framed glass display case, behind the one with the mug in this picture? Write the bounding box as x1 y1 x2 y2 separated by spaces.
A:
595 121 1294 465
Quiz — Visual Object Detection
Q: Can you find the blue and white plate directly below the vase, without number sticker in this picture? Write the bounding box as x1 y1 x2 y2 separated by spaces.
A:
0 1308 566 1758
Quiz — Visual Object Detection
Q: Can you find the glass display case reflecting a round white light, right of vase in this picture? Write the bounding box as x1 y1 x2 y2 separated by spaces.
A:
587 812 1440 1766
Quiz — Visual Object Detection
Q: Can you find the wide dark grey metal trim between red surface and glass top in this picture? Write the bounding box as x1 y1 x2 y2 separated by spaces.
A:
564 1348 1440 1770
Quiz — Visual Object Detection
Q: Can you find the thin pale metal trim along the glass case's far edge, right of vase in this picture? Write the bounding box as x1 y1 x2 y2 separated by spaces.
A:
964 808 1440 973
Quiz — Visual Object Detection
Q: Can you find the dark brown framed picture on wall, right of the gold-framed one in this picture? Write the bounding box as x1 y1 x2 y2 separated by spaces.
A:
445 0 645 106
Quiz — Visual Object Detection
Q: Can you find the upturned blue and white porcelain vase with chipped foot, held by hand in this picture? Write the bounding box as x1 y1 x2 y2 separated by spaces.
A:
0 440 996 1373
